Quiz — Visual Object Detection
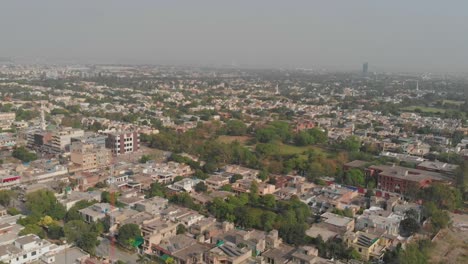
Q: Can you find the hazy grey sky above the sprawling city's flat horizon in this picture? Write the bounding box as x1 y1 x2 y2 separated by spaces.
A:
0 0 468 72
